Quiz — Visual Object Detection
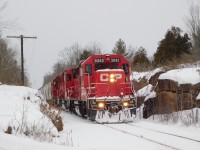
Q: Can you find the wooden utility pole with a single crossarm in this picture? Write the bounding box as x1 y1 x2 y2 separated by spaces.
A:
7 35 37 85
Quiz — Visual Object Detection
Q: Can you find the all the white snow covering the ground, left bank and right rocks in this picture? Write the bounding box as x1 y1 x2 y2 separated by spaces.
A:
0 63 200 150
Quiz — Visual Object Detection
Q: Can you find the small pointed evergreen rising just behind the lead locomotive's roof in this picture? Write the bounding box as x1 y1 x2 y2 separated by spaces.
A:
112 39 126 55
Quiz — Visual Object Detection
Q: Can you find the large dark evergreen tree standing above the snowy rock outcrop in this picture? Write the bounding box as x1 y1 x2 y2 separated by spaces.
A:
154 27 192 65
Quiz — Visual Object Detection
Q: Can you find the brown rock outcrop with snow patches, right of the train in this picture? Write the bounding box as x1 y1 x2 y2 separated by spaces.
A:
135 67 200 118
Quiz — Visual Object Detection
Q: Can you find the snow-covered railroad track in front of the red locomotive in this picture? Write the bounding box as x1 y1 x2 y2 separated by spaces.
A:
102 124 200 150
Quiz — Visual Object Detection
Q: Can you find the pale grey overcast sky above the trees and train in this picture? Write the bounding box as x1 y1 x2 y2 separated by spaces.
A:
1 0 193 88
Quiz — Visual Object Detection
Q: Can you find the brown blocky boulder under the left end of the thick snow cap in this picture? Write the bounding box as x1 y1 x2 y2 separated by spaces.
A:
155 79 178 93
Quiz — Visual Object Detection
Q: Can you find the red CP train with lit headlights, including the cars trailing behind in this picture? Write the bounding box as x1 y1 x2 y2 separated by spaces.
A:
40 54 136 123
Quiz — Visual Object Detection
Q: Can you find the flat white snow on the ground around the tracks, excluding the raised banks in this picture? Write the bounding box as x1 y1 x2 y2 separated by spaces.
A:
0 108 200 150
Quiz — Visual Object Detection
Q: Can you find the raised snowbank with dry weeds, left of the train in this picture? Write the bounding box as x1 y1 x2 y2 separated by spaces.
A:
0 85 58 140
